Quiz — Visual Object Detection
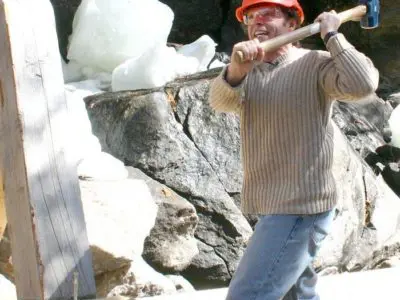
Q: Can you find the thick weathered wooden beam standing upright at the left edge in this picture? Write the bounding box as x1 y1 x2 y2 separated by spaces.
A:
0 0 96 300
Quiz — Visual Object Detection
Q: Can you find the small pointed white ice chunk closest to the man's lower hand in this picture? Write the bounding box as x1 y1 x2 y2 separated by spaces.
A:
177 35 217 72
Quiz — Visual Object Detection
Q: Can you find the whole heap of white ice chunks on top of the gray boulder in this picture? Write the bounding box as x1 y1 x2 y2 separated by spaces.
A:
63 0 224 91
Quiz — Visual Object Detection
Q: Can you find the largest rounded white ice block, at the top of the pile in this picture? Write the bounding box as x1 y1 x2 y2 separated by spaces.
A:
68 0 174 73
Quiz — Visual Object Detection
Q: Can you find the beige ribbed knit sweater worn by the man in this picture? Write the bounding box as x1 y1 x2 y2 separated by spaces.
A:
209 34 379 214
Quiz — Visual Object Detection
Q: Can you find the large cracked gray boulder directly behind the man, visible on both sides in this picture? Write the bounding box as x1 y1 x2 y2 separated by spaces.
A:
85 71 400 287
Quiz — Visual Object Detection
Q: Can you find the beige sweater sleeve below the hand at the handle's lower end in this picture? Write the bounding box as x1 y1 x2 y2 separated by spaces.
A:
208 66 246 113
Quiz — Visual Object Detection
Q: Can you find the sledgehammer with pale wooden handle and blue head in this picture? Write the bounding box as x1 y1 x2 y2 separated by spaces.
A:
236 0 380 61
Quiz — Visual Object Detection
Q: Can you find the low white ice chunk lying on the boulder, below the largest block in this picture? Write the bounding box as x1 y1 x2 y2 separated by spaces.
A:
112 45 199 91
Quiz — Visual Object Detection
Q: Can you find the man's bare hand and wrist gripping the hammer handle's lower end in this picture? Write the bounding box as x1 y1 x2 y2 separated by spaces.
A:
226 39 264 86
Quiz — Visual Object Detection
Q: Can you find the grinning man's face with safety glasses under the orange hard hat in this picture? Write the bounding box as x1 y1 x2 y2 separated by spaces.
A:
244 5 294 42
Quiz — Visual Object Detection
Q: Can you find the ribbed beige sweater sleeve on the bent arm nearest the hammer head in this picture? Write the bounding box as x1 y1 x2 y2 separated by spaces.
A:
319 33 379 100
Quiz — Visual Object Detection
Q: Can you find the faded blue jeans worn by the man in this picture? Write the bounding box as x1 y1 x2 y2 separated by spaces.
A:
226 209 335 300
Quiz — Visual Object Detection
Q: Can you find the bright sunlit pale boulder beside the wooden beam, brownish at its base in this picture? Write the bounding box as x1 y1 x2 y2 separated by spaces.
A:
79 179 158 275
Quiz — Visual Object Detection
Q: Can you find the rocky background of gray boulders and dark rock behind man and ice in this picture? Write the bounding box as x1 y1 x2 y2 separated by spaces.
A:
0 0 400 298
